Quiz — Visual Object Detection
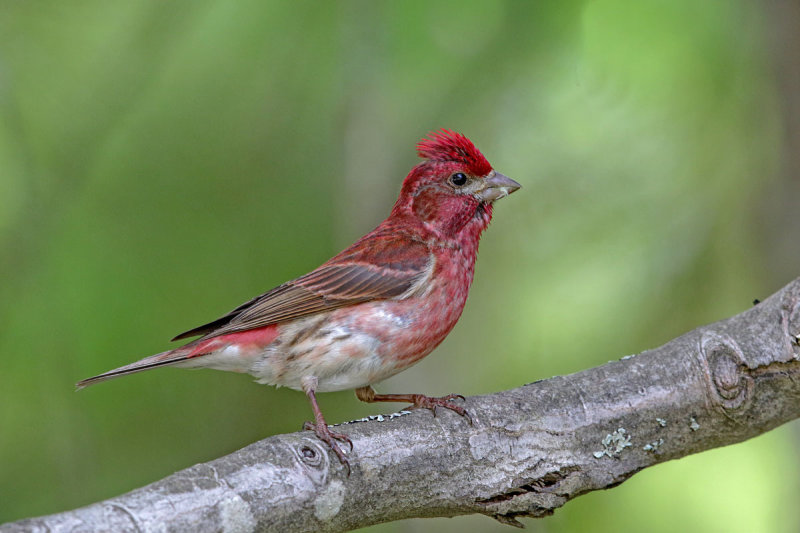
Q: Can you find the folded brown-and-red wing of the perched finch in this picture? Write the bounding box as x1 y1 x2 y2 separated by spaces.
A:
173 232 433 340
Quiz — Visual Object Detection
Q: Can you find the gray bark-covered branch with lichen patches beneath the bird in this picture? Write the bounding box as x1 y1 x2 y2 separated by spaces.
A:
0 278 800 532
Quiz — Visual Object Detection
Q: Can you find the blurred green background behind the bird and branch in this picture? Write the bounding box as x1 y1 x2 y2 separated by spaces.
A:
0 0 800 533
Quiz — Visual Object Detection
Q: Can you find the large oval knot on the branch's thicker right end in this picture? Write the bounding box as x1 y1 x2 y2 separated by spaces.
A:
700 331 754 414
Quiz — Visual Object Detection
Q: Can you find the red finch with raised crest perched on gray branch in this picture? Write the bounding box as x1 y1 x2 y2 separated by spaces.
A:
77 130 520 470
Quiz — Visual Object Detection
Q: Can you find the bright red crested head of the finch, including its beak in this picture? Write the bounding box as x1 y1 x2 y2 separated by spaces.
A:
392 129 520 234
